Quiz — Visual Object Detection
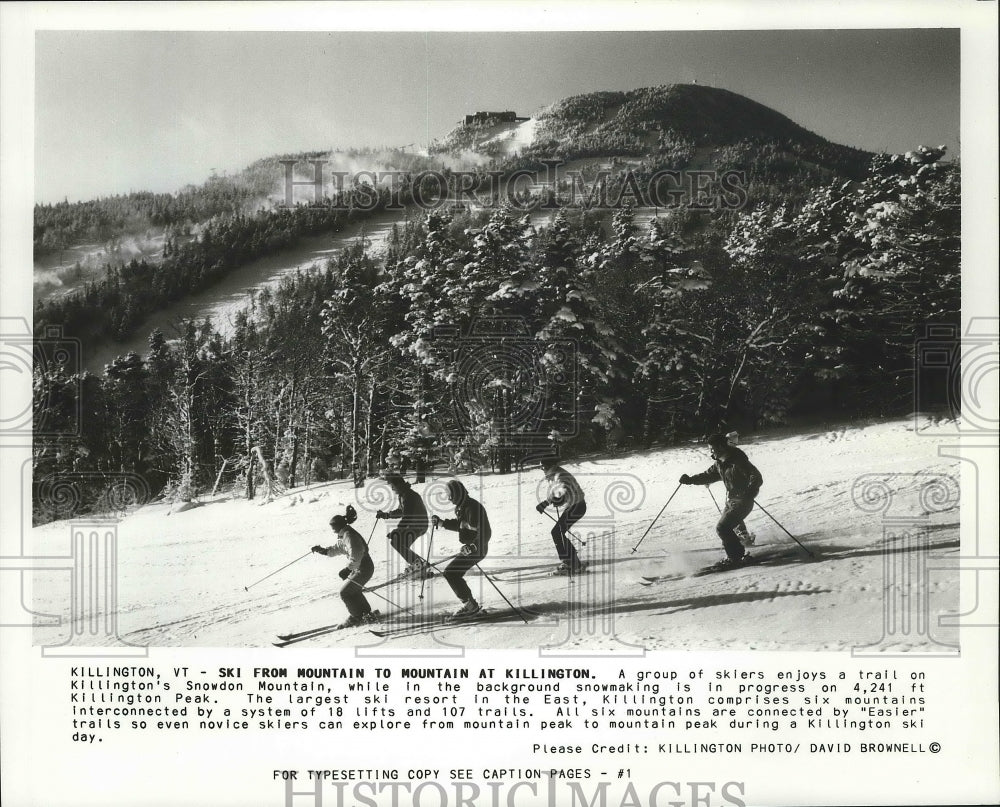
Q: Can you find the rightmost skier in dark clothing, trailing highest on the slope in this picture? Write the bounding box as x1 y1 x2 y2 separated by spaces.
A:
680 434 764 569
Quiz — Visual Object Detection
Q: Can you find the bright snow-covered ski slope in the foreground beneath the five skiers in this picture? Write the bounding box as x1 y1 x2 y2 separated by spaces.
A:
31 421 959 653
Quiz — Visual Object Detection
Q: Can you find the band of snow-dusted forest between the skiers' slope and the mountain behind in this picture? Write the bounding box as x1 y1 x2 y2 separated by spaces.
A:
33 143 960 520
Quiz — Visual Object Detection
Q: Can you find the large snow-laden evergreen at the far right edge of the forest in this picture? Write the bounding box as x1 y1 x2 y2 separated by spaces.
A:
795 146 961 411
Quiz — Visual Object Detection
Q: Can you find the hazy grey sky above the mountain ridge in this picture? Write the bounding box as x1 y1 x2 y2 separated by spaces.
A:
35 29 960 203
